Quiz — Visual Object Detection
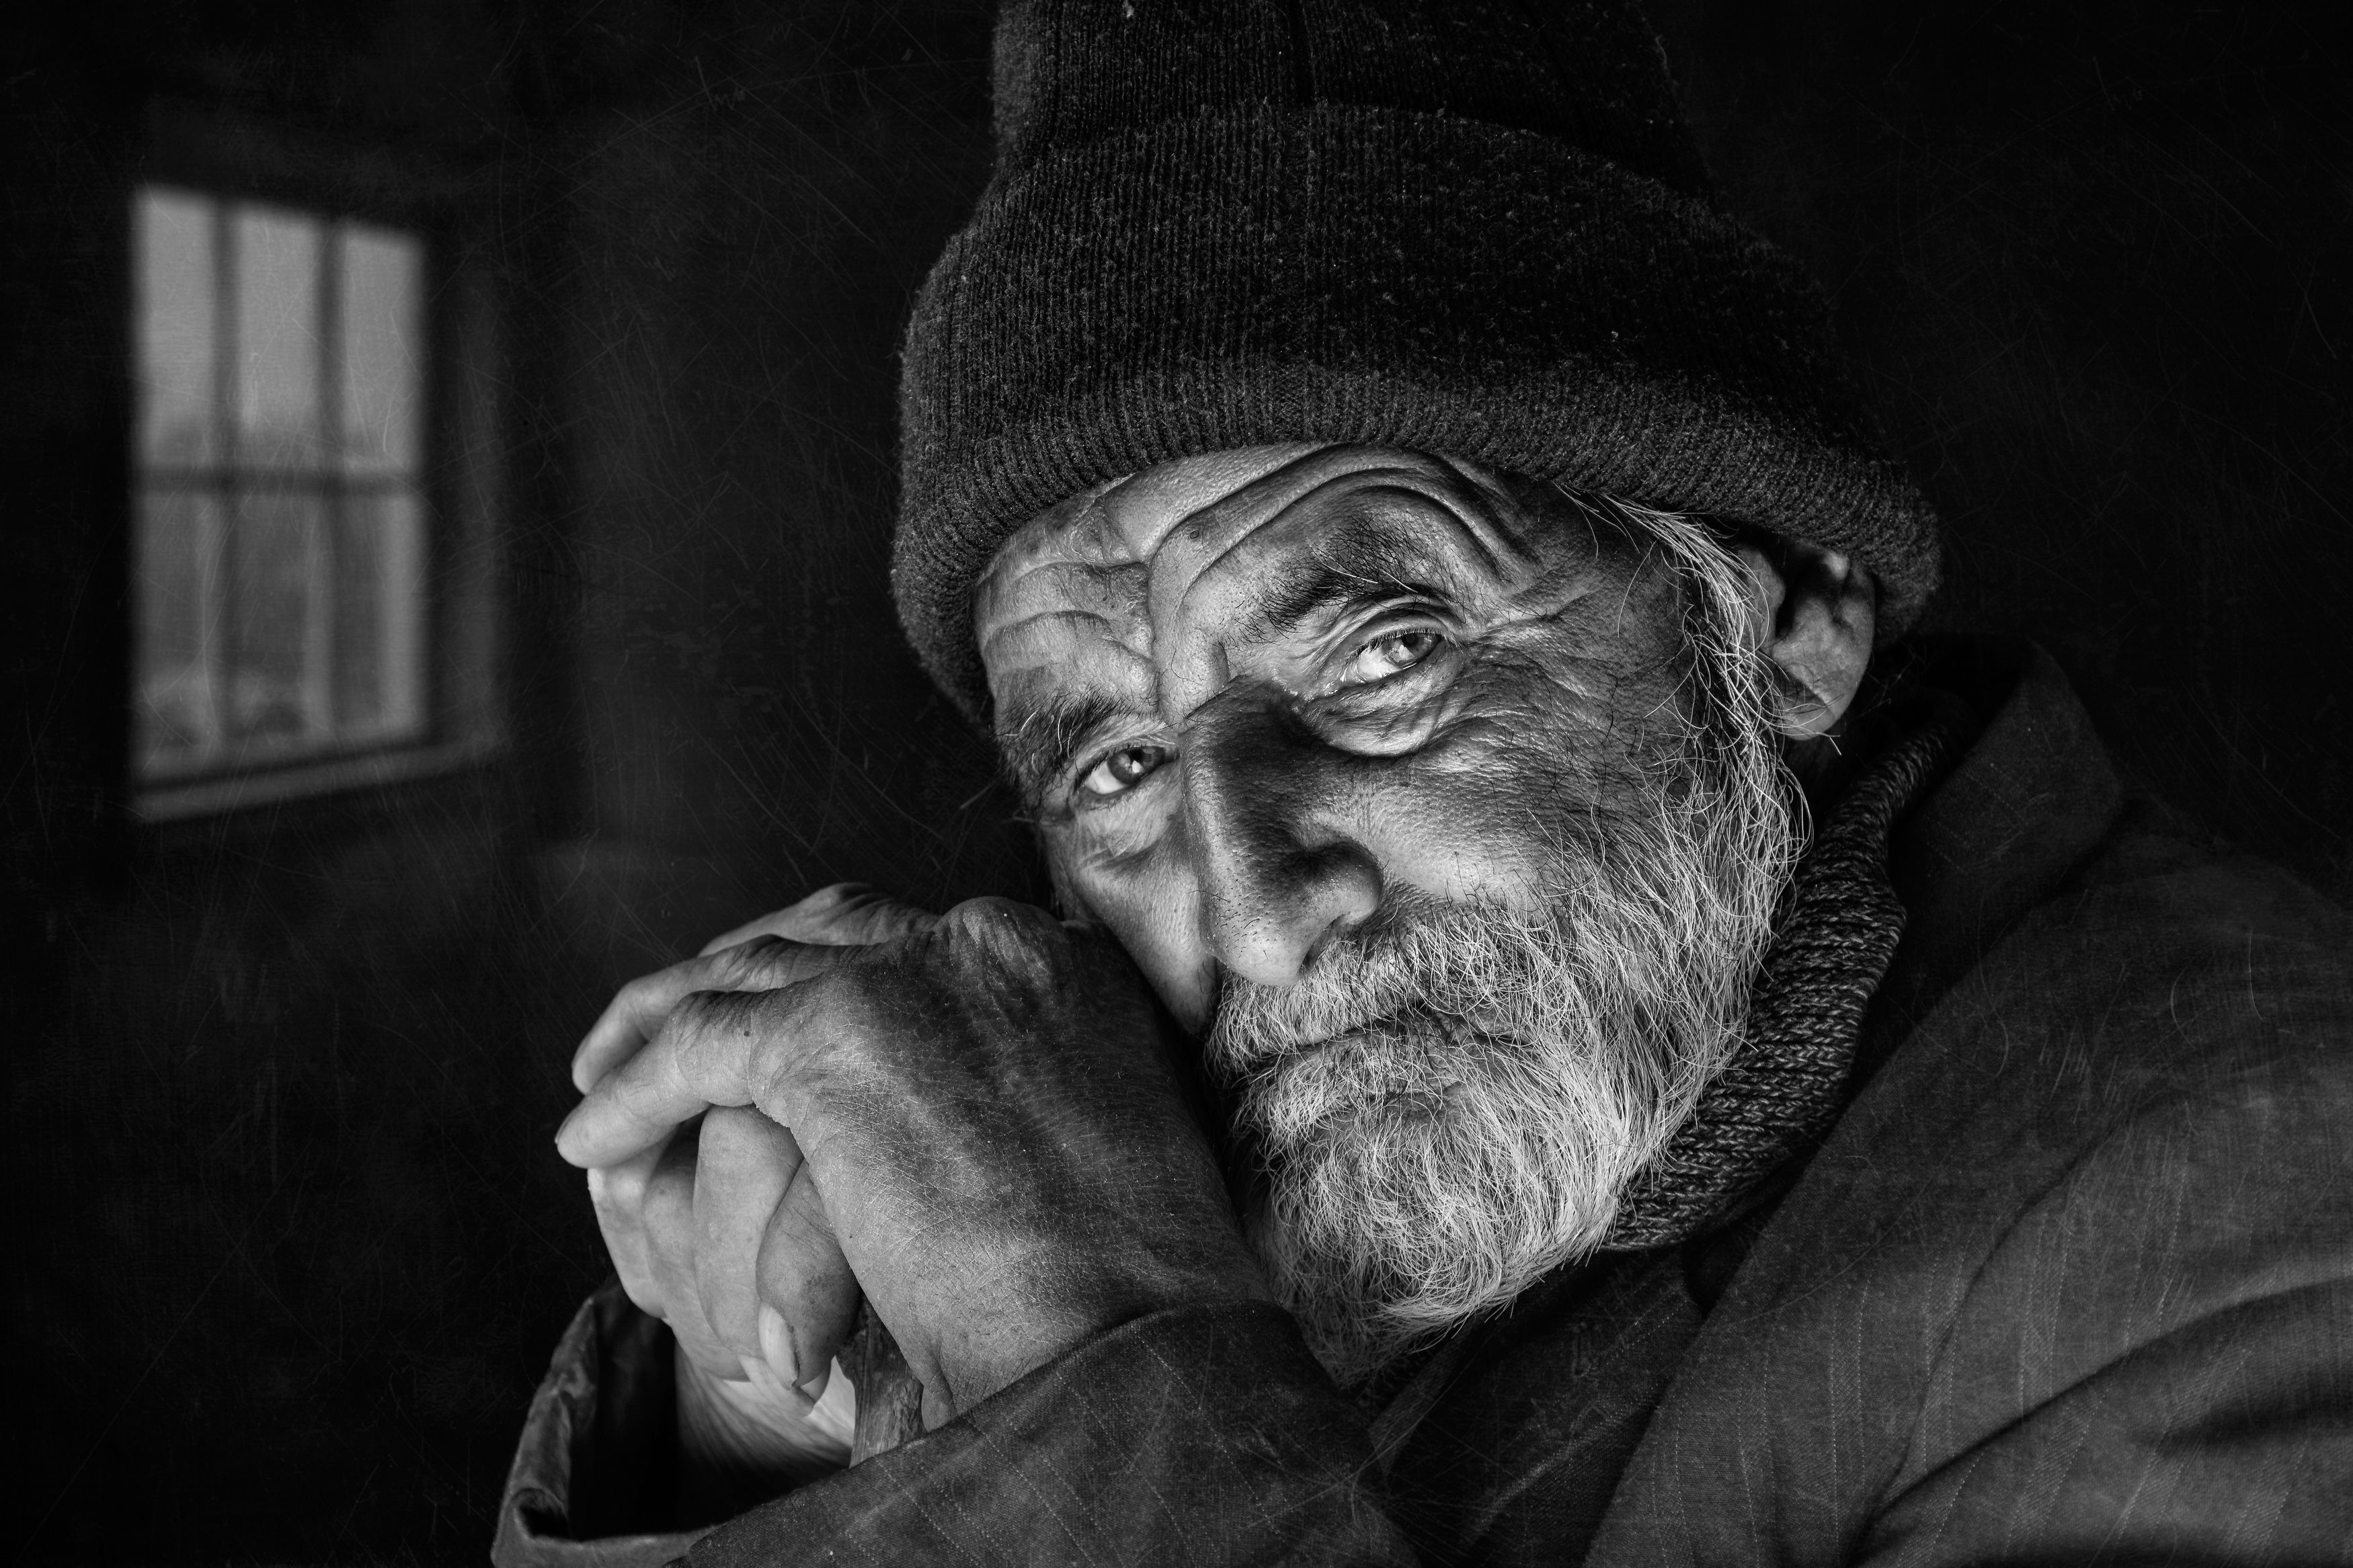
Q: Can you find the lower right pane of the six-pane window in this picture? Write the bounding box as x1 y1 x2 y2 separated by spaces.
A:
334 489 426 741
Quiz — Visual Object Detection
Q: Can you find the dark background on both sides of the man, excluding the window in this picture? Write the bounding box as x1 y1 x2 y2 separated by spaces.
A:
0 0 2353 1563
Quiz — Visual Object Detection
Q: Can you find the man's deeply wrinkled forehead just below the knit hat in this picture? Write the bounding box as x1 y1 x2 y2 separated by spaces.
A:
974 447 1525 710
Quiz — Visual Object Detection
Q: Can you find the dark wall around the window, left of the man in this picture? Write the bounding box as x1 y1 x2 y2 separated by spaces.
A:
0 0 1033 1563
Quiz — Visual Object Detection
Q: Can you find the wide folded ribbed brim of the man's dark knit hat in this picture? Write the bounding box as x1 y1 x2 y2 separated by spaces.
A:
892 104 1939 719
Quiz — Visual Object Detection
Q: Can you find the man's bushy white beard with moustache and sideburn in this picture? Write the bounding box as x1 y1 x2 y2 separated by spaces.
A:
1207 505 1802 1385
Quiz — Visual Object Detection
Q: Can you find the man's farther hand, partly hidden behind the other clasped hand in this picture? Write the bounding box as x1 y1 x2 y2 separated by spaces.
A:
572 884 936 1462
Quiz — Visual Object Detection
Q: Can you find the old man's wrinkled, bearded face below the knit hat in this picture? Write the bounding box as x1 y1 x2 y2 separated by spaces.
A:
977 447 1793 1373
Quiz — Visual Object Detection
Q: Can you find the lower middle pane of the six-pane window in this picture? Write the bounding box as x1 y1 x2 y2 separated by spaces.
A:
229 489 329 757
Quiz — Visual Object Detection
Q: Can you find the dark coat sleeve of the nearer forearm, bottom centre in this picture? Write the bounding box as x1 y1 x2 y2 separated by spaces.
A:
687 1303 1414 1568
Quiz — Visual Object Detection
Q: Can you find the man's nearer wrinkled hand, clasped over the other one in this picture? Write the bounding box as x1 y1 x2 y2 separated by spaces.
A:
558 898 1266 1425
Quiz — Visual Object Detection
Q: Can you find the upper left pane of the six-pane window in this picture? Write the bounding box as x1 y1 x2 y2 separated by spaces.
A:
132 190 214 463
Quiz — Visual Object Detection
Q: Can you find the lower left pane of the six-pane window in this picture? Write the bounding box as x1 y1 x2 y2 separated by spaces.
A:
132 487 221 774
